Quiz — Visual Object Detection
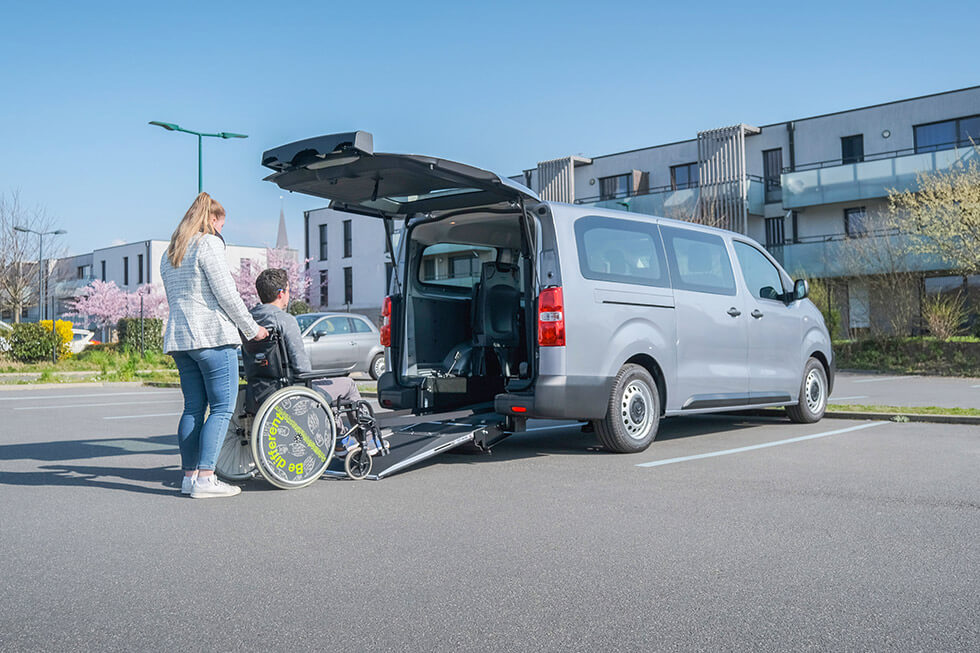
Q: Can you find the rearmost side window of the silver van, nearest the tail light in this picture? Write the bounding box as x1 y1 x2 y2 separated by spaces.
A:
575 216 670 288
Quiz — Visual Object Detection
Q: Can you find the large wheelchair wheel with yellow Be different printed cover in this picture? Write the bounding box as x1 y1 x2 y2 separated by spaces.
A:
251 386 336 490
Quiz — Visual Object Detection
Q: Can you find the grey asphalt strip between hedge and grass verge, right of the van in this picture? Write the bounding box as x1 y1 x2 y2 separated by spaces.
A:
830 372 980 408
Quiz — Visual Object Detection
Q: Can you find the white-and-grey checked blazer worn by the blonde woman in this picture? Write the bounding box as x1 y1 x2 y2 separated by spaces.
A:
160 234 259 353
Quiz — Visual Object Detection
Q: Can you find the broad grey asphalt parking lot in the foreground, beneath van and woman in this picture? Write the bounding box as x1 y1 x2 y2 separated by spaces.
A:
0 384 980 651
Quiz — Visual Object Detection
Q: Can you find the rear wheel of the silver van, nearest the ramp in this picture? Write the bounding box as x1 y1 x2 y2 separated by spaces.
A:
593 363 660 453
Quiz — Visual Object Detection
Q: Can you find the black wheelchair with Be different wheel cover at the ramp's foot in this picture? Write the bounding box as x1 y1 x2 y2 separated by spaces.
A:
215 329 388 490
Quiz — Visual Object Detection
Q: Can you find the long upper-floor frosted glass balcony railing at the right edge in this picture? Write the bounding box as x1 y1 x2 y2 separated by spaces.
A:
782 147 977 209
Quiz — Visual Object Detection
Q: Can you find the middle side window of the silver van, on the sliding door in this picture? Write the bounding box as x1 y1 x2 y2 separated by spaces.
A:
661 227 735 295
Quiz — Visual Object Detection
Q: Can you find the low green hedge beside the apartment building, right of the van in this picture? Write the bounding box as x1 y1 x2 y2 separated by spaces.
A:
834 338 980 376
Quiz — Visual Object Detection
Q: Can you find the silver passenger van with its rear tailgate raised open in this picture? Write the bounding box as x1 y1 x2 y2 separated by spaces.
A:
263 132 835 452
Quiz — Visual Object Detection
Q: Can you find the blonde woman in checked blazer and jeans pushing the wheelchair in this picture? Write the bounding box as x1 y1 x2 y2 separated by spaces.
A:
160 193 269 499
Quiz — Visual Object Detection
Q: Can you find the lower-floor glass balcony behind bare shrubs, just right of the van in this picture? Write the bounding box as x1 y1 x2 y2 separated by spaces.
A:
768 231 950 279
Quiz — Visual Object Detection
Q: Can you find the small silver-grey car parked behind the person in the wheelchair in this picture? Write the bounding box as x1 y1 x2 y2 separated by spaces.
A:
296 313 385 379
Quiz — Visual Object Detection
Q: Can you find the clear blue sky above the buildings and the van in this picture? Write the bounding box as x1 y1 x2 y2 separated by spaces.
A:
0 0 980 253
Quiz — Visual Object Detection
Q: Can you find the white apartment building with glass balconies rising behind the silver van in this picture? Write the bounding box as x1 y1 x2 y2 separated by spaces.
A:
512 86 980 332
